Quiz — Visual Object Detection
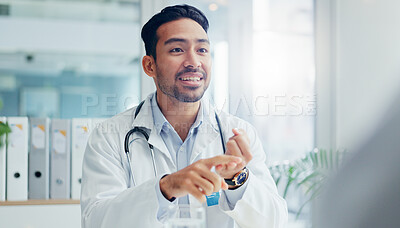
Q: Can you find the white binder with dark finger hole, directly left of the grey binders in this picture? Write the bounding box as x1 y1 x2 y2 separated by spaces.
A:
7 117 29 201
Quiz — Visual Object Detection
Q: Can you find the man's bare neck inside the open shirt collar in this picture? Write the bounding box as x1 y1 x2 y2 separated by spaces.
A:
157 93 200 141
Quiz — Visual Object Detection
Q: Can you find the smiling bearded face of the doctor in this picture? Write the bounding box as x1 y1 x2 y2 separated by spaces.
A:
154 18 211 102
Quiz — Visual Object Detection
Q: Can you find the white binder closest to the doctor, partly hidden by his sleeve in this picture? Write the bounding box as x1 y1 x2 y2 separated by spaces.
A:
71 118 92 200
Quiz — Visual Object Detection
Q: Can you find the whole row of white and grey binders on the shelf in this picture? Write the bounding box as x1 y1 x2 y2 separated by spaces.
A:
0 117 104 201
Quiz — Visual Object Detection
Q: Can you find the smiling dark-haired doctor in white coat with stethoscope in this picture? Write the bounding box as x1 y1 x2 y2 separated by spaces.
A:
81 5 287 228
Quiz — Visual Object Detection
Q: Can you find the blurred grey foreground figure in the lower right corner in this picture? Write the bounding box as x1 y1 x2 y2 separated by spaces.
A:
315 97 400 228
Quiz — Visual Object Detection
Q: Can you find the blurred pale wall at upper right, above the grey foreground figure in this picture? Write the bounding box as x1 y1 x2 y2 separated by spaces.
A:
315 0 400 150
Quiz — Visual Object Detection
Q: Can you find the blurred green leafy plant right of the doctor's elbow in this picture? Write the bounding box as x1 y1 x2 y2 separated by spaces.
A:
270 148 346 218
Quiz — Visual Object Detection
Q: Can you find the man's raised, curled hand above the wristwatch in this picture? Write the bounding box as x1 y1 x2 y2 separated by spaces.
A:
215 128 253 179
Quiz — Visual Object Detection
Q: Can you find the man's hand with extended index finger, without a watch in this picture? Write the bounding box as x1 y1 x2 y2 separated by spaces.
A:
160 155 243 202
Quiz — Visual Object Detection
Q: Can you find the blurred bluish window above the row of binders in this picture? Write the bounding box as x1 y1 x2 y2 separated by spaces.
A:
0 0 142 118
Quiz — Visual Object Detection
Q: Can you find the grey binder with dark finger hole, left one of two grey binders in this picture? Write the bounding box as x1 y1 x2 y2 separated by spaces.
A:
28 118 50 199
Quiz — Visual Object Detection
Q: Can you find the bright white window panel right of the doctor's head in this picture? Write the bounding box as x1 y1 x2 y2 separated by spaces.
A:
252 0 316 162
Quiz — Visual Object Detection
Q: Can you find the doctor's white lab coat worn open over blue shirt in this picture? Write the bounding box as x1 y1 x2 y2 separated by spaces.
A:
81 95 287 228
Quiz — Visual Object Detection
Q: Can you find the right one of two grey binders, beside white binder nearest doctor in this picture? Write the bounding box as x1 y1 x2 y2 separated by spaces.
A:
50 119 71 199
